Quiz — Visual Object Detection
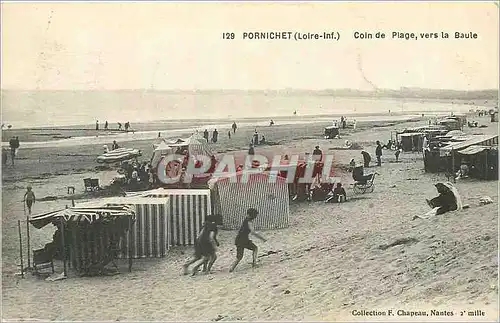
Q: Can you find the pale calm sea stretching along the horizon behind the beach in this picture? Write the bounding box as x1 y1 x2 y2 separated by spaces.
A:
1 91 471 147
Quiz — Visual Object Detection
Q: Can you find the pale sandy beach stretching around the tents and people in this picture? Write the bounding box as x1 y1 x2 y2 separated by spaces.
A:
2 110 498 322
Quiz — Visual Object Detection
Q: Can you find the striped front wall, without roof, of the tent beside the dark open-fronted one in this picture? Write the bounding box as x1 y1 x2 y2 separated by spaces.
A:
120 204 170 258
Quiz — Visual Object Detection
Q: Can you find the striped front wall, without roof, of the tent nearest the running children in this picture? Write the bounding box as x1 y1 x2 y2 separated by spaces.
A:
168 192 211 246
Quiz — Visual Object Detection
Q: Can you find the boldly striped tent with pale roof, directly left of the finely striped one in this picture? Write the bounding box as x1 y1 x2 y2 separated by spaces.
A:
127 188 212 246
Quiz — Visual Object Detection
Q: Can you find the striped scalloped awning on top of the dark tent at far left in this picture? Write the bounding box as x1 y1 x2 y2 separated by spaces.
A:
30 205 135 229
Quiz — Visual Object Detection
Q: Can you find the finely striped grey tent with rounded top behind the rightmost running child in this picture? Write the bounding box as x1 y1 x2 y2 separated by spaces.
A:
211 172 290 230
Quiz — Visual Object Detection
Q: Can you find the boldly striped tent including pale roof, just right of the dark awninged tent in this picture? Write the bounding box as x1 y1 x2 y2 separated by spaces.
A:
79 197 171 258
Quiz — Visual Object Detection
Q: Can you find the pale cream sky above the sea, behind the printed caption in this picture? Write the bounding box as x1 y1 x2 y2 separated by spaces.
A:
1 2 499 90
